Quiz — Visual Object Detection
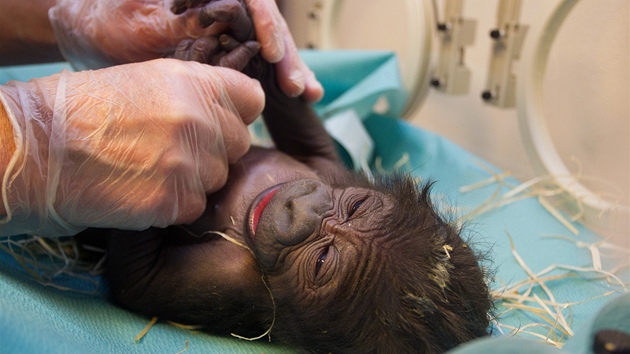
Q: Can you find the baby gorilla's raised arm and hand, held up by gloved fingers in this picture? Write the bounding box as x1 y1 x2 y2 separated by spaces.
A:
174 0 340 169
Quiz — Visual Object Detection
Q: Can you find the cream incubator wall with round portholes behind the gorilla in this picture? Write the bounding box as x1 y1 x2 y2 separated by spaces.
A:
283 0 630 244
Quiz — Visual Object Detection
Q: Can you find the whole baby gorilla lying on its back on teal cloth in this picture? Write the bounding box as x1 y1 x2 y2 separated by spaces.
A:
82 1 491 353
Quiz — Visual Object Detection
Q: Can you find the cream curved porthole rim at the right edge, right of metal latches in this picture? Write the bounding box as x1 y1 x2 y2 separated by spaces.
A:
516 0 628 233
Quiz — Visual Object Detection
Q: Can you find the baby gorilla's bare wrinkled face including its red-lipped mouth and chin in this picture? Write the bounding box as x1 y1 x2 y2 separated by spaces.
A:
185 148 394 300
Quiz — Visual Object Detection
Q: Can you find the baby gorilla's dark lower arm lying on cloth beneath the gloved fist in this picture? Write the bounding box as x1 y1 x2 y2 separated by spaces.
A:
105 226 272 335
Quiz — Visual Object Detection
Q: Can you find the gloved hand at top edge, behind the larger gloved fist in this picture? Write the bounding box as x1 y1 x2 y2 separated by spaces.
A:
48 0 221 70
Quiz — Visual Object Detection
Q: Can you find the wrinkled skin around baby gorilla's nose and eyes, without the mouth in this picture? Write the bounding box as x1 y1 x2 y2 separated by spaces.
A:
247 179 393 296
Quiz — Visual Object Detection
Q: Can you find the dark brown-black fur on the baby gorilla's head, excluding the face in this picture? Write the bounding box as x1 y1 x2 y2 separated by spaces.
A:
256 174 492 353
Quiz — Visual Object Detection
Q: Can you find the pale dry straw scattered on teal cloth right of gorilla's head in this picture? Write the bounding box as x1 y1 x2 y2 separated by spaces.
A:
460 160 630 347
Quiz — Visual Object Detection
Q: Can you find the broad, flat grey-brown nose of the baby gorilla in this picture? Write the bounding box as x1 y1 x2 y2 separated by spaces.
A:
272 180 333 246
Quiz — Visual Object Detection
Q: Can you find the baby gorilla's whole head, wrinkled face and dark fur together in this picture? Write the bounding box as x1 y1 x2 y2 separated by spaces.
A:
250 176 491 353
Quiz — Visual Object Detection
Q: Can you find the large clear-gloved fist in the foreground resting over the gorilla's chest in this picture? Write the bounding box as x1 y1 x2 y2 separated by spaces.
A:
0 59 264 236
